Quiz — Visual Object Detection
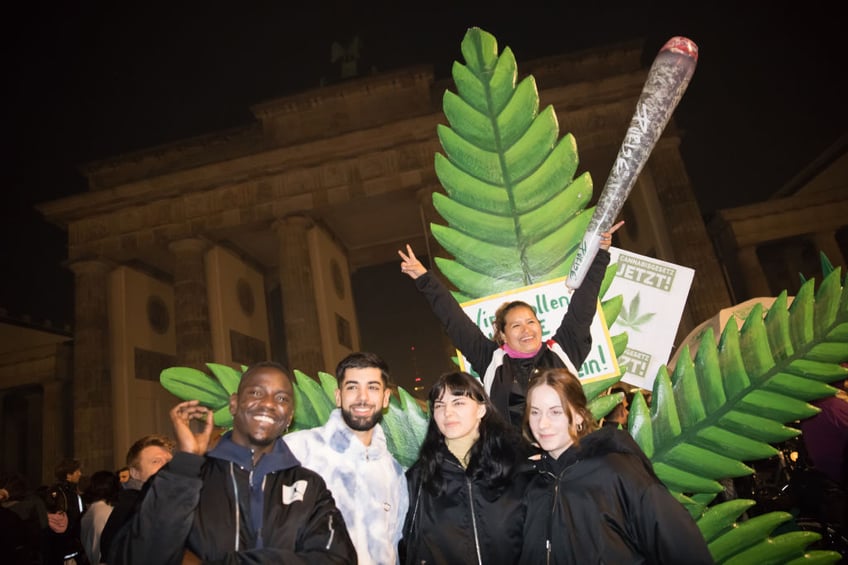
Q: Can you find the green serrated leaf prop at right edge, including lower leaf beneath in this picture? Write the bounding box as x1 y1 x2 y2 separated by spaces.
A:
628 268 848 563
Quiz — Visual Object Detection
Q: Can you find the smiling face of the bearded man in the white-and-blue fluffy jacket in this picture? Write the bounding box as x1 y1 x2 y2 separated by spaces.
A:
336 367 391 438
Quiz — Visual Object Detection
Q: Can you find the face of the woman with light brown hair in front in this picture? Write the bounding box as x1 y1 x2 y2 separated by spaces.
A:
527 384 583 459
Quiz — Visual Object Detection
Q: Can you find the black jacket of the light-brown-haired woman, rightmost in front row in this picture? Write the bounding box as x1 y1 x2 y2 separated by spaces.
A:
520 427 713 565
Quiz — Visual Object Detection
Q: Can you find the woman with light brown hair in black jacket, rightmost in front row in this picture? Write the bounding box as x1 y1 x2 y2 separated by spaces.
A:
519 369 712 564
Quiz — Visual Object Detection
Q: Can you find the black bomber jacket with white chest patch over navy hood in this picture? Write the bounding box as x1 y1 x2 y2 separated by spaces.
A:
109 433 356 565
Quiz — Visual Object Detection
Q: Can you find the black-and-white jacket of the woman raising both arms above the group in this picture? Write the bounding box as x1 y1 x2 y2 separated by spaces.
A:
415 249 610 428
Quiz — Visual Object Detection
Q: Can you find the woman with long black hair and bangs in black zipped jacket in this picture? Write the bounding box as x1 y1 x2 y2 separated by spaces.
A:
401 372 530 565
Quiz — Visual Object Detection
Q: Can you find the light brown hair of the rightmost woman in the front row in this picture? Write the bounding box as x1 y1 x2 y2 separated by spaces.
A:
521 369 598 445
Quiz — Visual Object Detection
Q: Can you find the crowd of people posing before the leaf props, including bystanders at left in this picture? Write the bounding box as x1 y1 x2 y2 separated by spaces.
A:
4 224 724 565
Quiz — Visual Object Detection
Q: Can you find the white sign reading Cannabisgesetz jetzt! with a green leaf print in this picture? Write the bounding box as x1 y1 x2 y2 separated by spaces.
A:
605 247 695 390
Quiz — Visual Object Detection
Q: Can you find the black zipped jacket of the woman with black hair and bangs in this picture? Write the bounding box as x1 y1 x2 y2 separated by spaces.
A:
400 446 532 565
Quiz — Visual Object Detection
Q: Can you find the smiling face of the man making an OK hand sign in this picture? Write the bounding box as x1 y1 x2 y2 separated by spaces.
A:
230 367 294 454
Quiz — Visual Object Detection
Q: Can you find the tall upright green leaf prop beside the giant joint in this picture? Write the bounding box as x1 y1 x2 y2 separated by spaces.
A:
431 28 592 302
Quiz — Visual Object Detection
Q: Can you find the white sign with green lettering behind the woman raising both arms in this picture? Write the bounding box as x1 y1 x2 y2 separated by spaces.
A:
457 277 619 382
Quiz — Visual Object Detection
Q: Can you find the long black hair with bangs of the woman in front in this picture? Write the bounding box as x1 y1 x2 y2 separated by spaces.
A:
418 372 525 496
